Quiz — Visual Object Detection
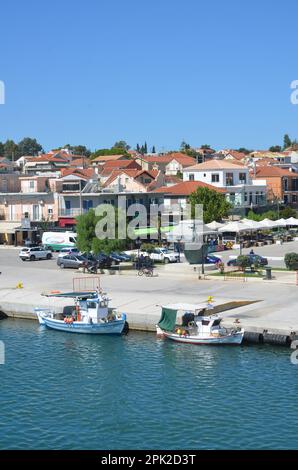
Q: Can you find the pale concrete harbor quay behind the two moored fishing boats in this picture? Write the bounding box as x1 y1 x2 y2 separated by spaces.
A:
0 246 298 345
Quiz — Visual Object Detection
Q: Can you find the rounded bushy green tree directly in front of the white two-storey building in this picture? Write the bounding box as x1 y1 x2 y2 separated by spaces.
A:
189 188 232 224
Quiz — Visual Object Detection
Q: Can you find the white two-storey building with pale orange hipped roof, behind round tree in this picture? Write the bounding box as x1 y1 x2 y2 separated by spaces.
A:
183 160 266 207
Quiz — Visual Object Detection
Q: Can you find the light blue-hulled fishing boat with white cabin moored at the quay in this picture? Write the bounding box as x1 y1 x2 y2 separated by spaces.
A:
35 290 128 335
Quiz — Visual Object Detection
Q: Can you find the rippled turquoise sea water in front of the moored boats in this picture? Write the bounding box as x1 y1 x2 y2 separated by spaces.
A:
0 320 298 450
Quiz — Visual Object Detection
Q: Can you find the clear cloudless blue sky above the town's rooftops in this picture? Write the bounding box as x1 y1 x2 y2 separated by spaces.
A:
0 0 298 150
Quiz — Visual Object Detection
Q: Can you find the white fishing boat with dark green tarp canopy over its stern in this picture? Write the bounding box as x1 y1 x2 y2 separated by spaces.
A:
156 304 244 345
